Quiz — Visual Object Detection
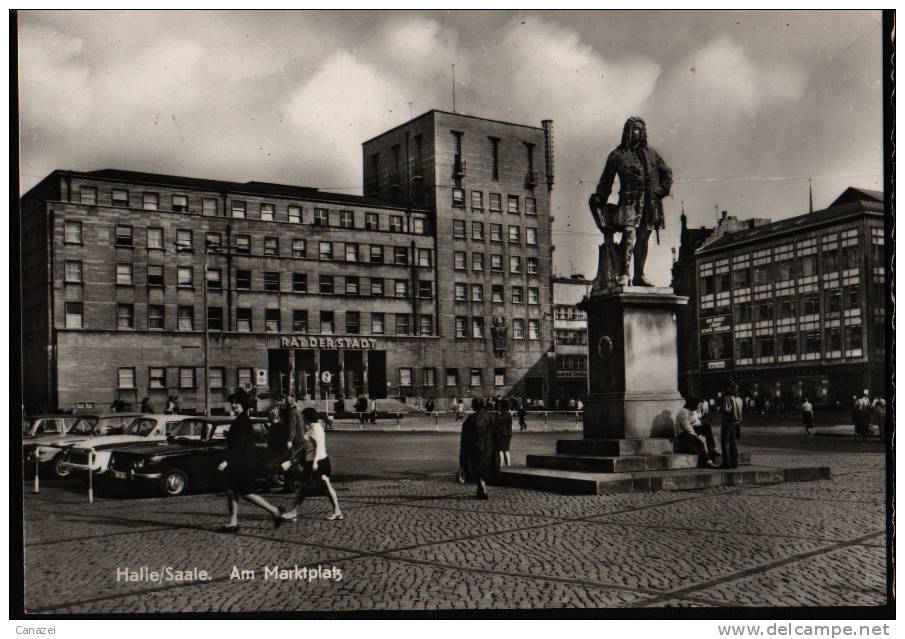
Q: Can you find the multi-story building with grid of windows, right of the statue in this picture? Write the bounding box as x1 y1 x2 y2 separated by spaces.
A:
680 188 886 406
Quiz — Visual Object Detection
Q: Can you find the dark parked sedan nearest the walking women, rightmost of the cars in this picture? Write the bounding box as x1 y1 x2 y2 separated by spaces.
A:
109 417 279 496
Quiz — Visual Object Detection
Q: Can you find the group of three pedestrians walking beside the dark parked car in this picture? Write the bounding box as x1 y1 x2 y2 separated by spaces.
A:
217 393 344 533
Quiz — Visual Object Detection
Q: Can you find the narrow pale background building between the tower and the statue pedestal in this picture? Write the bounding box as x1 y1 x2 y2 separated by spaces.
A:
550 275 591 408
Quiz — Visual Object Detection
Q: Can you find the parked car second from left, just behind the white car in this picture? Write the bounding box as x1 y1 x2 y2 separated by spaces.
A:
22 413 135 479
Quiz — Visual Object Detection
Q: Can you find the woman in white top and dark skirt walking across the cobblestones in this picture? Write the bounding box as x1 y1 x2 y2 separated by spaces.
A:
283 406 345 521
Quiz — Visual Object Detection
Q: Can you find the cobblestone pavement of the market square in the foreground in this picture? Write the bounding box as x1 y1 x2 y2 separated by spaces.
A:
17 435 886 614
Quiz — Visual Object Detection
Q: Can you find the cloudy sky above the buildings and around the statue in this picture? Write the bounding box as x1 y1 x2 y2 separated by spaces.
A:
19 11 883 284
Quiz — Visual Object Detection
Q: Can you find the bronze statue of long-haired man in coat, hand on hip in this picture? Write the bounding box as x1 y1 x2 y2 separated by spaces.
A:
592 117 672 286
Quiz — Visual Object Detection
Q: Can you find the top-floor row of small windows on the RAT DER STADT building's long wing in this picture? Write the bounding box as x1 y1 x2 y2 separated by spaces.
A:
79 186 427 235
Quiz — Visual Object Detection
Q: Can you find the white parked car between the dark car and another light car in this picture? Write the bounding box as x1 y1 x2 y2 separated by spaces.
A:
63 415 191 476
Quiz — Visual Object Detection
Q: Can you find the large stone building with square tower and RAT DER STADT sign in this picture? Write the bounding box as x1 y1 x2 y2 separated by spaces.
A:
21 111 553 410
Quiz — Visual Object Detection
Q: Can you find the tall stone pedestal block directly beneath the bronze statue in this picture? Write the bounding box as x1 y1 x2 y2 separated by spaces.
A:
579 286 688 439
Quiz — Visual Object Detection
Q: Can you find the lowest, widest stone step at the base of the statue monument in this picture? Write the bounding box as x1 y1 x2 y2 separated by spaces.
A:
499 466 831 495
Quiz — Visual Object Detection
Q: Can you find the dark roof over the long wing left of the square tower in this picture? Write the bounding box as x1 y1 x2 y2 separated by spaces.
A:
60 169 422 210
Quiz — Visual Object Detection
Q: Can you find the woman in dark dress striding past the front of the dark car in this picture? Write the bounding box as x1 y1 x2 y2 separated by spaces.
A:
217 395 285 533
